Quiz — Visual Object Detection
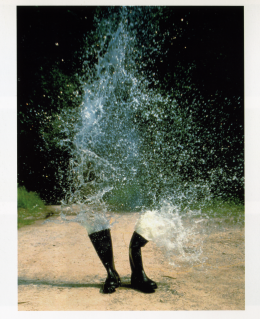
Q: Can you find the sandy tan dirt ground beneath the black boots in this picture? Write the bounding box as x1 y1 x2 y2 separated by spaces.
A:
18 206 245 311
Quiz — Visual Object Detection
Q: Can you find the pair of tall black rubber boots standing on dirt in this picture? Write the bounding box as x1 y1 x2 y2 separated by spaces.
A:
89 229 157 293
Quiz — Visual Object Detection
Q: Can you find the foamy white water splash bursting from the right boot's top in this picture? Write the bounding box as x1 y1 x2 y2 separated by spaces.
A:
135 201 206 266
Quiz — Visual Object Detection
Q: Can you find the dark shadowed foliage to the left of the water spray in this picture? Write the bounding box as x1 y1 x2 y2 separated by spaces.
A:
17 6 94 202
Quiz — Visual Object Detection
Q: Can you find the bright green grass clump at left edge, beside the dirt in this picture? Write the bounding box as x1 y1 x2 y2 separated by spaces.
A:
17 187 46 228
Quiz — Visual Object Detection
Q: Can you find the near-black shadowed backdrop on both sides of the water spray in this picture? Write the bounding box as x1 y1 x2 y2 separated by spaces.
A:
17 6 244 203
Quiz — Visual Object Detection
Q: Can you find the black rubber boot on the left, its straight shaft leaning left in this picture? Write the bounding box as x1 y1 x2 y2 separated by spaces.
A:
89 229 121 294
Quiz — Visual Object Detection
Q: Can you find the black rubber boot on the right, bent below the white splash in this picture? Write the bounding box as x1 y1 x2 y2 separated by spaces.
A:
129 232 157 292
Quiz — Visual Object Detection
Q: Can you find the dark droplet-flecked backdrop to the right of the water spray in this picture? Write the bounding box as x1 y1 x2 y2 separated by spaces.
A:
130 7 244 199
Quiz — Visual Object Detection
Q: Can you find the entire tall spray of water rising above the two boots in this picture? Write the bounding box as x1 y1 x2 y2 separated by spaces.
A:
50 8 244 264
